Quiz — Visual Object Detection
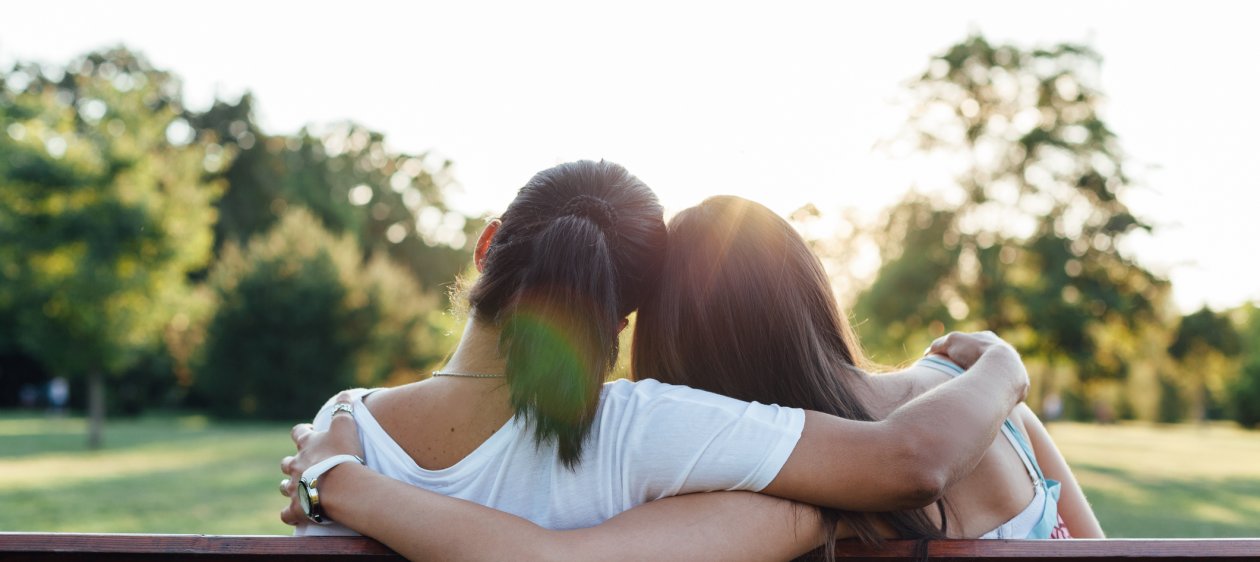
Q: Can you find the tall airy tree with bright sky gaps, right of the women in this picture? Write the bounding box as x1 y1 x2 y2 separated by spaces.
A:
856 35 1168 413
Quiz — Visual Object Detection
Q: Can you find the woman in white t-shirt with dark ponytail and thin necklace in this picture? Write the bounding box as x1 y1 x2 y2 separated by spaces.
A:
282 163 1027 554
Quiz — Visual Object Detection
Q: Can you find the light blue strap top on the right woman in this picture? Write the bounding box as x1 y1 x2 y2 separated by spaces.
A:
916 355 1061 538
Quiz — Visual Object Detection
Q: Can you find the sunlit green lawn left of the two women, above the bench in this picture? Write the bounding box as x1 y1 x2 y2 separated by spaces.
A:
0 415 292 534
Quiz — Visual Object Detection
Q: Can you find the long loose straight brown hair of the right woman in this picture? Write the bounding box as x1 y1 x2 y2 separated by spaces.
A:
631 195 945 559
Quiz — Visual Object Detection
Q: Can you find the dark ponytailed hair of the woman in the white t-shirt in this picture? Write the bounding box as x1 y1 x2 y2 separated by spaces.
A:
469 160 665 467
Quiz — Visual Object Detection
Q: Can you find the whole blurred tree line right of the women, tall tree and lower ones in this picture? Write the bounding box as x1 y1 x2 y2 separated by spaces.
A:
826 35 1260 425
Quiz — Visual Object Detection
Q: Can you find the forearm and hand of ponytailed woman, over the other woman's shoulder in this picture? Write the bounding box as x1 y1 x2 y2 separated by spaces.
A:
885 345 1027 490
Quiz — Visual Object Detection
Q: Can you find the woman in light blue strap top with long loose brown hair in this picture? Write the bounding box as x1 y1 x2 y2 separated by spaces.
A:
631 197 1101 551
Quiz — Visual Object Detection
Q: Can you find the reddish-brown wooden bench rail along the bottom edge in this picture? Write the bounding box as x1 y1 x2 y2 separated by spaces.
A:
0 533 1260 562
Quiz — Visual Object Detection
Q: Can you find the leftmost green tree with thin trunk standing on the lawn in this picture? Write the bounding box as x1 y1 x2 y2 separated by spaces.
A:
0 49 221 447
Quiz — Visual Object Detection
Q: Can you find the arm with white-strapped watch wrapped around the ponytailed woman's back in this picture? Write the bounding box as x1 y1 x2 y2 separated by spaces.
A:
281 415 823 561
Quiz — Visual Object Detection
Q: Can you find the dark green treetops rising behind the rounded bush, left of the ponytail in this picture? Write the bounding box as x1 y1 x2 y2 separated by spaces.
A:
188 95 480 290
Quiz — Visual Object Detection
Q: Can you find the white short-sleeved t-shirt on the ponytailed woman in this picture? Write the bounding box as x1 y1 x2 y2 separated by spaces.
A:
296 379 805 534
